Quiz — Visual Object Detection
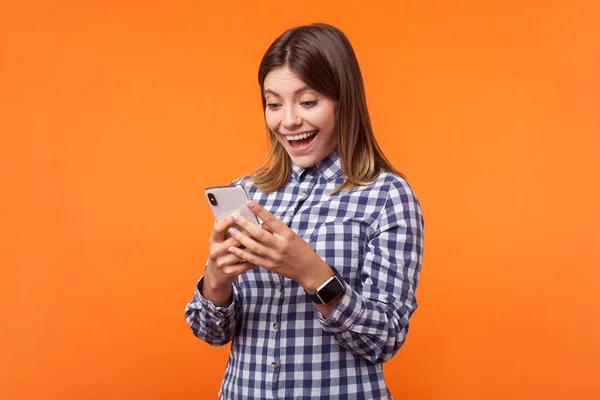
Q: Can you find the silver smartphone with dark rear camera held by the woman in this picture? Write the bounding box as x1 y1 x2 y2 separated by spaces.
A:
204 185 260 230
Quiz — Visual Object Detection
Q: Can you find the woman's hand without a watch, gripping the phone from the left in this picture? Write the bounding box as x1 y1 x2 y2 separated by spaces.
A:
202 216 256 306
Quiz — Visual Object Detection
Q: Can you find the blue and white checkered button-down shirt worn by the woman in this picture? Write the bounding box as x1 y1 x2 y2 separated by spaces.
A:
185 150 423 399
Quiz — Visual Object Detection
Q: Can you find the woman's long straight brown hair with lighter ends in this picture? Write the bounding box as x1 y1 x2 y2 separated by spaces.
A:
252 24 402 193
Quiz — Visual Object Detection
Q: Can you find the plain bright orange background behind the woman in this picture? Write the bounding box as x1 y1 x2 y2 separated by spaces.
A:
0 0 600 399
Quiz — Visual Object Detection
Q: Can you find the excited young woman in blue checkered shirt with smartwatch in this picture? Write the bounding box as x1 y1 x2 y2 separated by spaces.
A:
186 24 423 399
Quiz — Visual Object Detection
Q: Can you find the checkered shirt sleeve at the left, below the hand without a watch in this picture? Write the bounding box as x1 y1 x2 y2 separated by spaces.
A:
185 276 238 346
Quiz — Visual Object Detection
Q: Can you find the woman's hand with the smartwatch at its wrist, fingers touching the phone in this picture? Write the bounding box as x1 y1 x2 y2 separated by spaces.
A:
227 201 333 293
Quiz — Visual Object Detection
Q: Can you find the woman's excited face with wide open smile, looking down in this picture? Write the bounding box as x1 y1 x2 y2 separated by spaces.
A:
264 66 338 168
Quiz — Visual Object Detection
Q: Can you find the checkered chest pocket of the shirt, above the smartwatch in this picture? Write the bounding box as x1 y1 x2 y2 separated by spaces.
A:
310 221 365 287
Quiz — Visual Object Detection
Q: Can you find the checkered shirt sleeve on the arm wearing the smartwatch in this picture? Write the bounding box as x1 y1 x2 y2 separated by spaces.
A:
318 181 424 363
